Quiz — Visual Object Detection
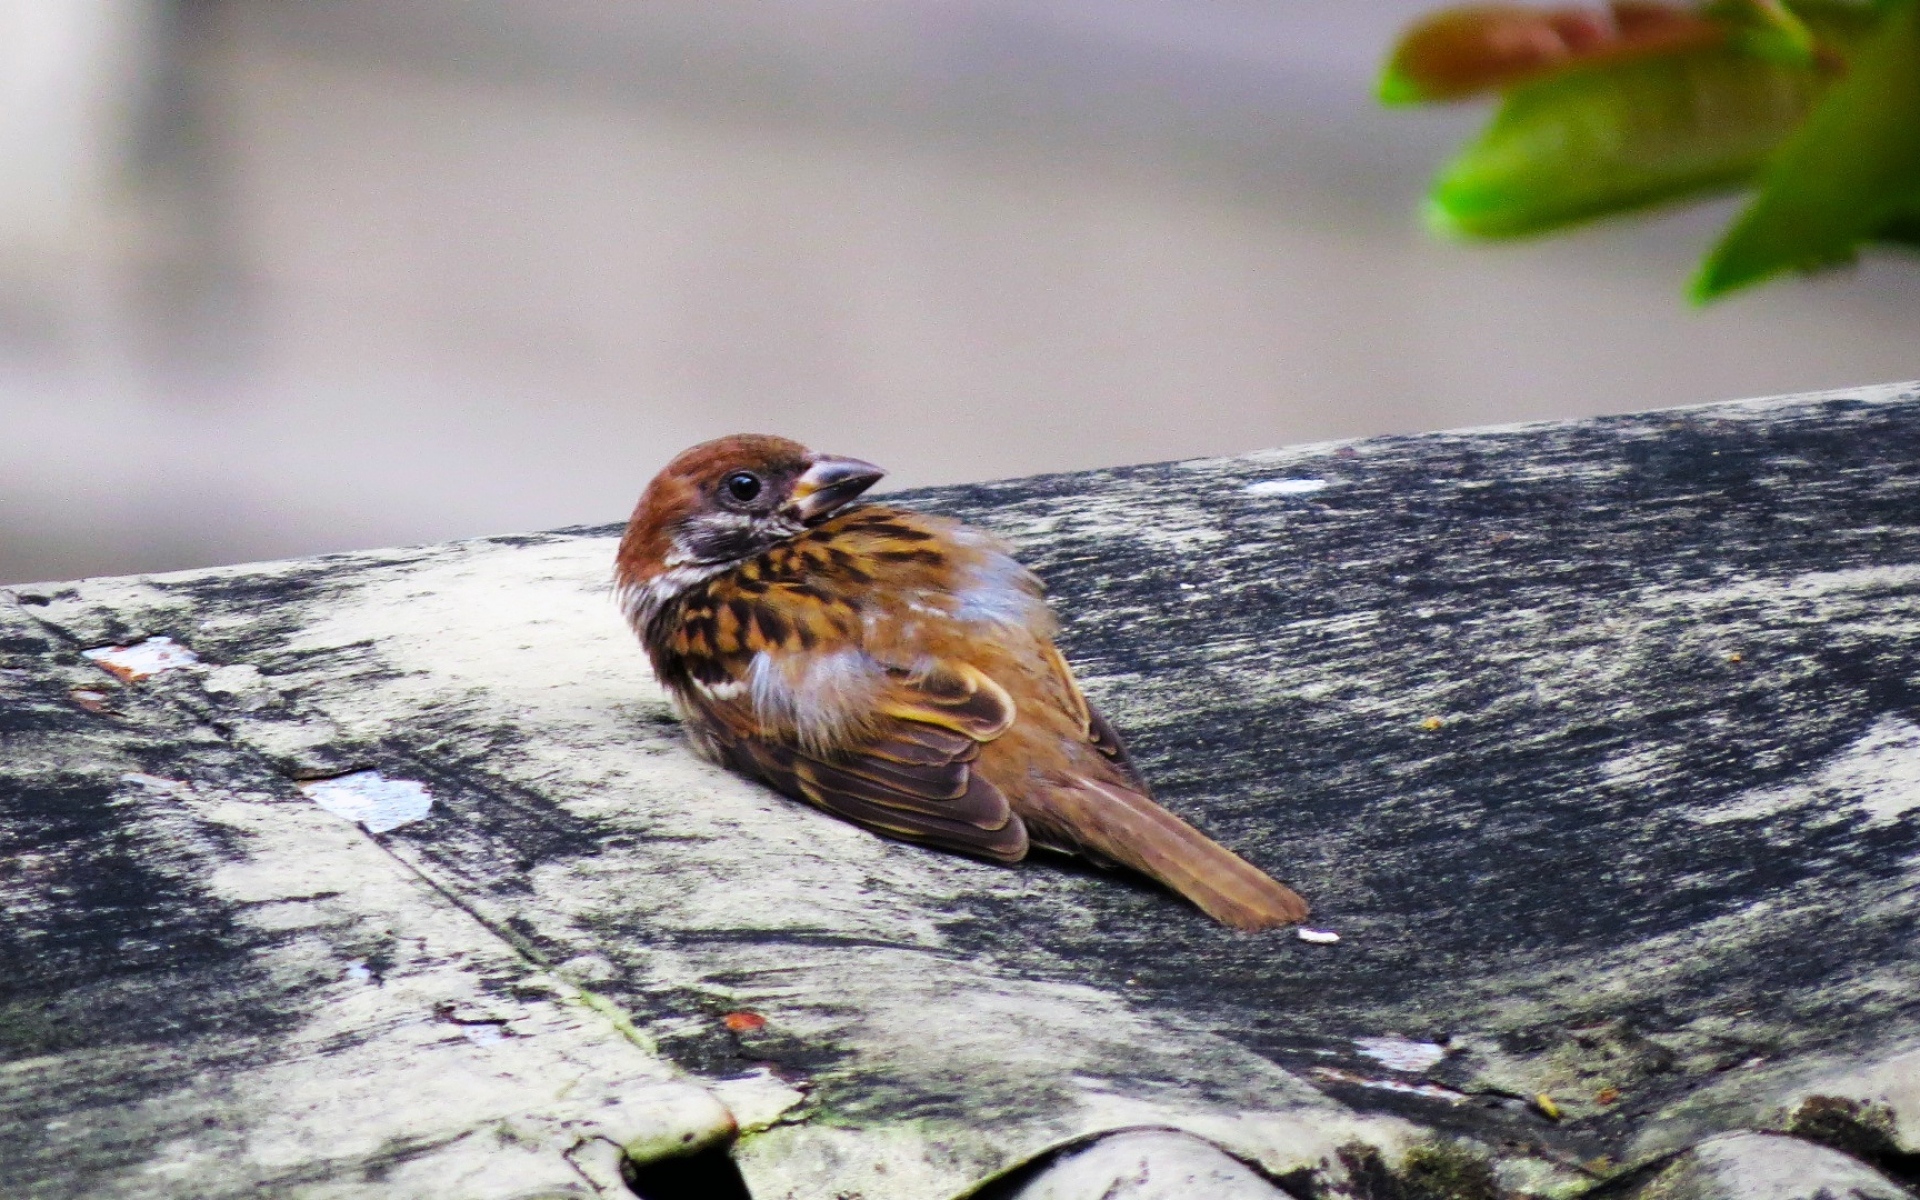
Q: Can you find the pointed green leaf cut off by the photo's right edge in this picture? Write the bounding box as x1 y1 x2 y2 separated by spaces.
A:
1693 0 1920 301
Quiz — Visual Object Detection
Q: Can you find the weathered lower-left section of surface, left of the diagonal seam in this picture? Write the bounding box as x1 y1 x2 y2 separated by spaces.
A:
0 601 732 1200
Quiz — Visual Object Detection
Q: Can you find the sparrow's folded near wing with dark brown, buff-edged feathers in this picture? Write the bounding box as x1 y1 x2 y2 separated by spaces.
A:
695 662 1027 862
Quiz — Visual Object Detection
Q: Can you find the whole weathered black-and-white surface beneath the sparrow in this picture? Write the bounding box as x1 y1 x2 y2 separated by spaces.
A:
0 386 1920 1200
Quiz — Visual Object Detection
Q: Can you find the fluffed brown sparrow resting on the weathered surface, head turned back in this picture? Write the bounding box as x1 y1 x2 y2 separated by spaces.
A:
614 434 1308 929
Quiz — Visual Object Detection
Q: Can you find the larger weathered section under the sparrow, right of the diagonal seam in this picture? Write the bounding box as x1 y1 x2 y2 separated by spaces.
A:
3 386 1920 1200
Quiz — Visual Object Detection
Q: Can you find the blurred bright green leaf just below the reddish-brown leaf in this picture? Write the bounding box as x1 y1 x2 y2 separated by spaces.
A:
1428 46 1828 238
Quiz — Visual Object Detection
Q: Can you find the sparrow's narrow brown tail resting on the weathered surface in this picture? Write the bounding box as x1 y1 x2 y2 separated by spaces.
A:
1044 778 1308 929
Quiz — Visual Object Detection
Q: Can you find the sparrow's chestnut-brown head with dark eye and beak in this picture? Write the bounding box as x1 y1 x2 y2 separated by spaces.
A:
614 434 887 620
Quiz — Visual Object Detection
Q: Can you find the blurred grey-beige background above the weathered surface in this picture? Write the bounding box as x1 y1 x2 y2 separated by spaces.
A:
0 0 1920 582
